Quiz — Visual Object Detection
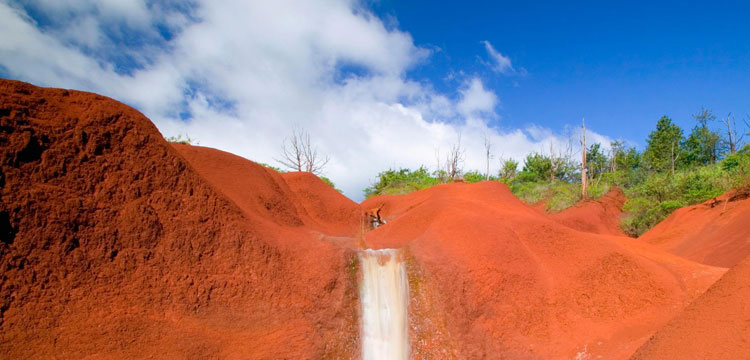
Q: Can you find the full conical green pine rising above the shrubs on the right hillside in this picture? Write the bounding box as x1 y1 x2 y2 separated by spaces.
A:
643 116 684 171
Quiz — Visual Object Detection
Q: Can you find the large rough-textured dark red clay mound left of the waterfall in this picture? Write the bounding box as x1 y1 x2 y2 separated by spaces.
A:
0 80 358 359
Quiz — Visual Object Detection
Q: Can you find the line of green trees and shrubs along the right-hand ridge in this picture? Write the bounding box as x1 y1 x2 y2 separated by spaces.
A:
364 109 750 236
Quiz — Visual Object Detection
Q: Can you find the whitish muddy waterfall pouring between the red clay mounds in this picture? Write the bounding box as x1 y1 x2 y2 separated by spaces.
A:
359 249 409 360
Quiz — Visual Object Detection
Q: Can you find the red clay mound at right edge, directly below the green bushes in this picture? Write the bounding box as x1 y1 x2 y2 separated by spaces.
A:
639 188 750 267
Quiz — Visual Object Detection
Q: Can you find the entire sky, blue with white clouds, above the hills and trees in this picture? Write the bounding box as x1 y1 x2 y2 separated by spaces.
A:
0 0 750 200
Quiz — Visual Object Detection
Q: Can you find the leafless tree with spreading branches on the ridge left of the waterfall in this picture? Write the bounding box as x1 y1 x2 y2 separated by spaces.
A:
276 129 330 175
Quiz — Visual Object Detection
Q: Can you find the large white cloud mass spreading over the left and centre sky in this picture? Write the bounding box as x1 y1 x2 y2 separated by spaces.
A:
0 0 606 200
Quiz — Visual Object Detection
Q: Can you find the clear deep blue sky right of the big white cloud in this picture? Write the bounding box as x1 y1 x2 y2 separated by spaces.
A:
372 0 750 146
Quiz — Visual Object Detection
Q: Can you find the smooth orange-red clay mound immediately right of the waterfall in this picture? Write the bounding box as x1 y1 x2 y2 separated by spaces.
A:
362 182 724 359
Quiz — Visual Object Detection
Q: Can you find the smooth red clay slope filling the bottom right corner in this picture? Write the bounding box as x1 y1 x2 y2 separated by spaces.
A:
632 257 750 360
